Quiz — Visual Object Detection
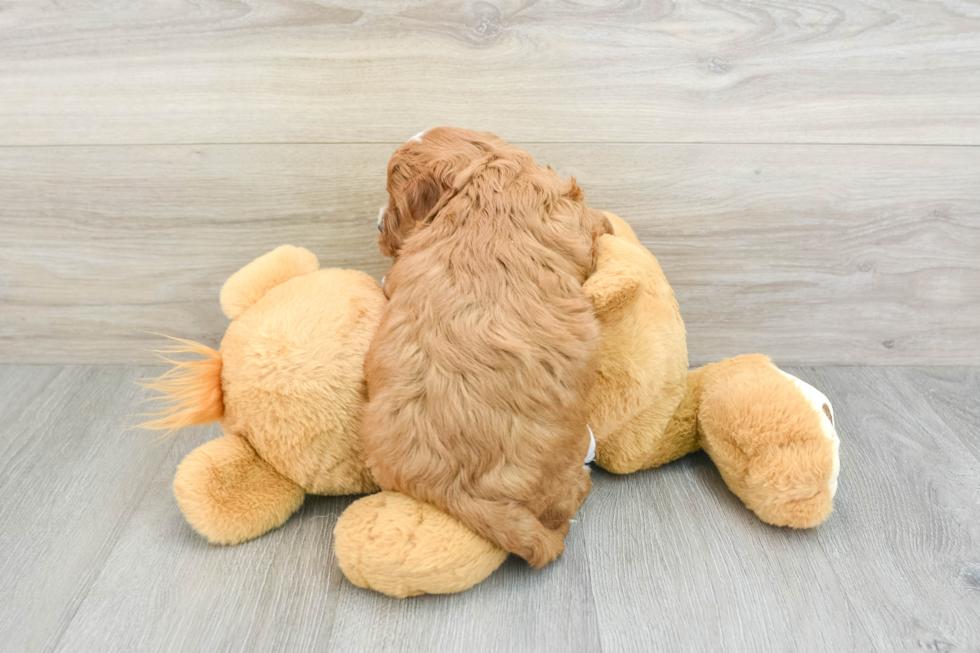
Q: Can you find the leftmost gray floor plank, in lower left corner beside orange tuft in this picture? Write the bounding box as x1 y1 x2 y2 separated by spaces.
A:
0 367 170 652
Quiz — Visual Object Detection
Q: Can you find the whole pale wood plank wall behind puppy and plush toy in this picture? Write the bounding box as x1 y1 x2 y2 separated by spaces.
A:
0 0 980 364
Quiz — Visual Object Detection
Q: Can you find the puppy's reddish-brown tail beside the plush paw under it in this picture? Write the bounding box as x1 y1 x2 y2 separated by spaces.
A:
446 494 565 567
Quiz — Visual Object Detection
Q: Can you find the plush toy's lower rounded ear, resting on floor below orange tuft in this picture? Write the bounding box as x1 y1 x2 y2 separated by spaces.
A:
174 434 305 544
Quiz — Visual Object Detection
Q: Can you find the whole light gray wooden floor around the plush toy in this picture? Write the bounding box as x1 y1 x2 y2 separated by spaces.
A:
0 366 980 653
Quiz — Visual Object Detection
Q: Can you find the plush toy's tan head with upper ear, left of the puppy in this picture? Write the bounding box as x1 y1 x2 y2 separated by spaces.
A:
221 247 385 494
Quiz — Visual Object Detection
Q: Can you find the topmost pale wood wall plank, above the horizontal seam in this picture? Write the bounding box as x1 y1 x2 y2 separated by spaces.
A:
0 0 980 144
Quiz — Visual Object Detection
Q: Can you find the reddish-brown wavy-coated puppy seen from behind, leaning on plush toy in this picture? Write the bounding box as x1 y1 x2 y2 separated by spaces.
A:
361 128 612 566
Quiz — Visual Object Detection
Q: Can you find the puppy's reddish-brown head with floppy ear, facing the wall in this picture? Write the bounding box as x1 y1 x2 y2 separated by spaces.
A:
378 127 507 258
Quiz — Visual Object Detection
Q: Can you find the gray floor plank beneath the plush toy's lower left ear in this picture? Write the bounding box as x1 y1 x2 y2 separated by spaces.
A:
56 427 350 653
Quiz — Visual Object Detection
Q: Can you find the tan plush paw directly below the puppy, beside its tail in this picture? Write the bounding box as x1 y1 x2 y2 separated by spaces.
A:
334 492 507 598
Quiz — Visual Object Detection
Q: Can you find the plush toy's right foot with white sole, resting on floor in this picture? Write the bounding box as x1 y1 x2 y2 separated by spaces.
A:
697 356 840 528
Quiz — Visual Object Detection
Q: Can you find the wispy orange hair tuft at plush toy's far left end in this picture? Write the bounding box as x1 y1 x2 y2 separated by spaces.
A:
139 336 225 433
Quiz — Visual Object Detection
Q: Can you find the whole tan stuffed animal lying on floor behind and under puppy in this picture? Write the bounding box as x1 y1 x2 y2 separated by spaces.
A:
145 214 838 597
